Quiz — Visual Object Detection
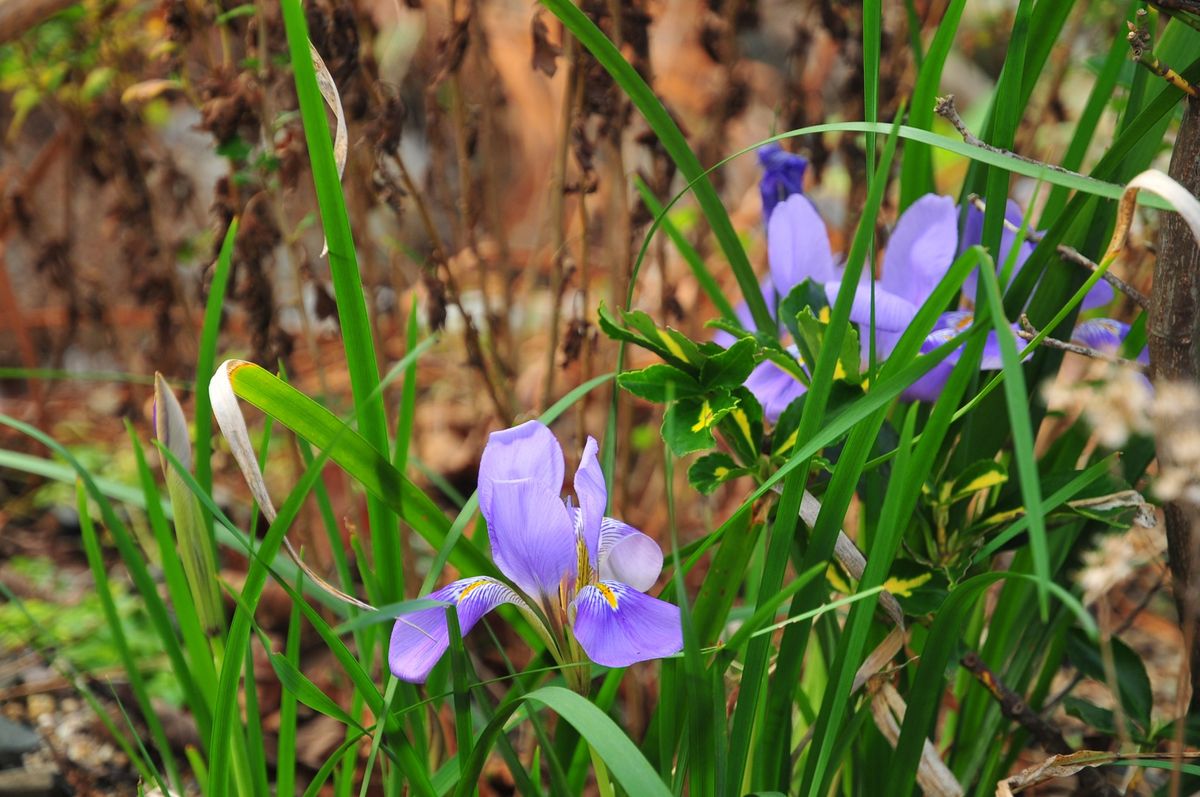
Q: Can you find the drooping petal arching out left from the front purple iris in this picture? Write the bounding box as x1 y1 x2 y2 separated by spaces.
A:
388 577 524 683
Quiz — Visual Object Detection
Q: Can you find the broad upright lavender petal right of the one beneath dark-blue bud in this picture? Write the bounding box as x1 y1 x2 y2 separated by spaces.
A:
880 193 959 307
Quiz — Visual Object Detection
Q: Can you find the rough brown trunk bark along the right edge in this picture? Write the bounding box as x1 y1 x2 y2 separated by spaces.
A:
1146 100 1200 711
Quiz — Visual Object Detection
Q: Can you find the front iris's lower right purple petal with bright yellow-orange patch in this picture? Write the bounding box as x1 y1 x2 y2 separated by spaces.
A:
574 581 683 667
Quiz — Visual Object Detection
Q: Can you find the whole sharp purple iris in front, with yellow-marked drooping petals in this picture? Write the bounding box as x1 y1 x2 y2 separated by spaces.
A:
388 420 683 683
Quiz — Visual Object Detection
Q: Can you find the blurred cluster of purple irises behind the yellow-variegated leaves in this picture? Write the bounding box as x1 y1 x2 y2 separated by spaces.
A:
716 144 1129 421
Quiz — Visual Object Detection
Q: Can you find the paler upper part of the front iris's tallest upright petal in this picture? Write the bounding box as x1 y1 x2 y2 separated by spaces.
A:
479 420 564 522
